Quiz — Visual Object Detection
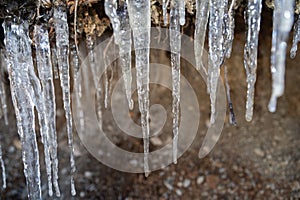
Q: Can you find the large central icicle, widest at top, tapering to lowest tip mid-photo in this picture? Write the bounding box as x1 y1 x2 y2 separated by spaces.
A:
128 0 151 176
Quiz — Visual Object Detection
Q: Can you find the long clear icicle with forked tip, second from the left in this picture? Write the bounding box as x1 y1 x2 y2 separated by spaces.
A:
34 25 60 196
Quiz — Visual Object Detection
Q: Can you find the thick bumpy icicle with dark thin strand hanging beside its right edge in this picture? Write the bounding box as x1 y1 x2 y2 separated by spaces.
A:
207 0 226 124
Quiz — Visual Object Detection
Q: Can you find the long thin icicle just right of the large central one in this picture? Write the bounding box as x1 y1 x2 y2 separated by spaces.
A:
169 0 181 164
